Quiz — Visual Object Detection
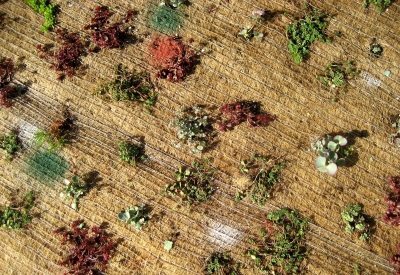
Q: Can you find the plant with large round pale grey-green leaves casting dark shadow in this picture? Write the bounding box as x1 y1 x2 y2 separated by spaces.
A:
311 135 354 175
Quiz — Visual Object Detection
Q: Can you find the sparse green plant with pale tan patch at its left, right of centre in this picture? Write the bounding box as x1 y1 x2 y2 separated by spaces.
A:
239 155 285 206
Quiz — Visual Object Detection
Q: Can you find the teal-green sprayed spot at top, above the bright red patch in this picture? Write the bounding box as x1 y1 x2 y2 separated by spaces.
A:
148 5 182 33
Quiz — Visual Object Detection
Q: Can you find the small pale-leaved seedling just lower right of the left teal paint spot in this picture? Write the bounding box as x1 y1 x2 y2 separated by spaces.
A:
60 175 90 211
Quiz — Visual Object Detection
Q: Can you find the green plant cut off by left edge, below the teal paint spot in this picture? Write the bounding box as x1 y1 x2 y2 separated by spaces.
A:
0 191 36 230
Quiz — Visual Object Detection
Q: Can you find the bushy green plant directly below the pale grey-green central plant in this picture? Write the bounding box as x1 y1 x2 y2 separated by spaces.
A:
162 159 214 206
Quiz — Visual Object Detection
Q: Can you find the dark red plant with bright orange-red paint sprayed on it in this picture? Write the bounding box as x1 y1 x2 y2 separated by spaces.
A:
150 37 196 82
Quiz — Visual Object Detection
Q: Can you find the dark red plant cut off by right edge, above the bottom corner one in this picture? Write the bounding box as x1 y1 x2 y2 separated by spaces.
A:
383 177 400 226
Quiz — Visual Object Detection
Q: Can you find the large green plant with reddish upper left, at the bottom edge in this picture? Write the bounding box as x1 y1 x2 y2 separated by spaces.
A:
246 208 308 274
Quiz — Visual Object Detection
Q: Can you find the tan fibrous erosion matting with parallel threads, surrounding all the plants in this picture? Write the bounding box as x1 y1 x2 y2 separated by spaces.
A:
0 0 400 275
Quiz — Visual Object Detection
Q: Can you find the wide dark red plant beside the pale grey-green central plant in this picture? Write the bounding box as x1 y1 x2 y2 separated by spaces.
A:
218 101 276 132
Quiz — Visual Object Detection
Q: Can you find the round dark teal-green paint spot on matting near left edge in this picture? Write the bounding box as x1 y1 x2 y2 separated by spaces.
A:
27 151 69 185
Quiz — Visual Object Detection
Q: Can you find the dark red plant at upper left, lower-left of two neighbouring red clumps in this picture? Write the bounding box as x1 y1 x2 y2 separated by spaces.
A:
36 29 84 80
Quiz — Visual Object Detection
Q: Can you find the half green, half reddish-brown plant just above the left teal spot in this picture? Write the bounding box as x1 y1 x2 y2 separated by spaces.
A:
34 110 74 151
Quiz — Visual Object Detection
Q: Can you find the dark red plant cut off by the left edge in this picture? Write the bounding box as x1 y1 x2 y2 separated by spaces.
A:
0 58 15 108
